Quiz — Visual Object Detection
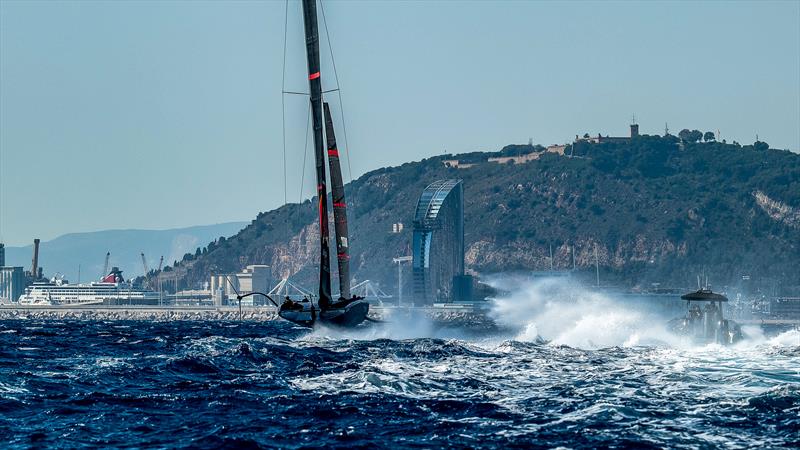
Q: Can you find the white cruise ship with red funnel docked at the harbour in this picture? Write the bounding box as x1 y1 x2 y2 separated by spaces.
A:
19 267 159 306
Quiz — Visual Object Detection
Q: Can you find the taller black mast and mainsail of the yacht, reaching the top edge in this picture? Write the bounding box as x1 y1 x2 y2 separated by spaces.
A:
303 0 331 309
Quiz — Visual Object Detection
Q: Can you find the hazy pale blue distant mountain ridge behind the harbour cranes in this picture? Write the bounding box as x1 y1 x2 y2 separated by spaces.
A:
6 222 247 282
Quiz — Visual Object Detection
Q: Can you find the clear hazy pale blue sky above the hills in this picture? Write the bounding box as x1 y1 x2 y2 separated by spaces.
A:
0 0 800 245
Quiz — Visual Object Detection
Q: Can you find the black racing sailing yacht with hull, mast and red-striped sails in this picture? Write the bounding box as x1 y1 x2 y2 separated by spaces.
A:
278 0 369 327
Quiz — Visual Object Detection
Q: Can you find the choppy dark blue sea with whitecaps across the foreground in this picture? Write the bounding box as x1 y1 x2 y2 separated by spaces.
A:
0 320 800 448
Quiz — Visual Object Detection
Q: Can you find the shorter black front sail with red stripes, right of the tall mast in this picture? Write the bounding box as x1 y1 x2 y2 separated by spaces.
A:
322 102 350 298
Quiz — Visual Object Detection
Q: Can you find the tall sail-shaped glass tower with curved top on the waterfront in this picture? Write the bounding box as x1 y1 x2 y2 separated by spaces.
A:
411 180 464 305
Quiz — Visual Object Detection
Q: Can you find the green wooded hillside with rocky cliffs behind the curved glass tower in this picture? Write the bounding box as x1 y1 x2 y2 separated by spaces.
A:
155 136 800 296
